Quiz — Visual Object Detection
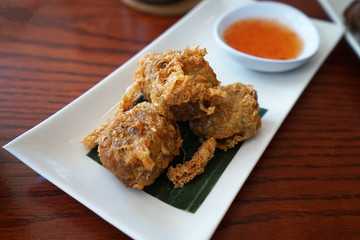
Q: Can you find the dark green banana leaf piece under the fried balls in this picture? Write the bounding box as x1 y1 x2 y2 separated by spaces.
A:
87 108 267 213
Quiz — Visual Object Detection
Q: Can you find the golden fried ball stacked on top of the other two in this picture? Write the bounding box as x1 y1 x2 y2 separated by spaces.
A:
119 47 225 121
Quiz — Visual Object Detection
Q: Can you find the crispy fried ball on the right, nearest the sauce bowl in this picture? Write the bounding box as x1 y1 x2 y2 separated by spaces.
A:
190 83 261 151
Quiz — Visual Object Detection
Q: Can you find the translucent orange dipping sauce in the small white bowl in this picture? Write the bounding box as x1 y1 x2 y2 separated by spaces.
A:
224 18 303 60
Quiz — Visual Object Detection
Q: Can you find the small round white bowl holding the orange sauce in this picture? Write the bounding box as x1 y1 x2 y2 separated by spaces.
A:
213 1 320 72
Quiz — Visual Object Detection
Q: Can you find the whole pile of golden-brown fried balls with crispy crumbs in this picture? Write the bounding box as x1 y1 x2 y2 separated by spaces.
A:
82 47 261 189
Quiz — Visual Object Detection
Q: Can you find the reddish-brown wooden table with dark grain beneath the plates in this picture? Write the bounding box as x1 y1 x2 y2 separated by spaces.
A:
0 0 360 239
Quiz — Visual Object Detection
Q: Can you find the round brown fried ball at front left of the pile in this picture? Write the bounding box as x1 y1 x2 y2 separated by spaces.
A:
95 102 182 189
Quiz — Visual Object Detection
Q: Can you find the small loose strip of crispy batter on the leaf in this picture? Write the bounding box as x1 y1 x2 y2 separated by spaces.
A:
166 138 216 188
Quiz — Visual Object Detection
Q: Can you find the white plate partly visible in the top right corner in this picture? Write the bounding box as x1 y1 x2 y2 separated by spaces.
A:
318 0 360 58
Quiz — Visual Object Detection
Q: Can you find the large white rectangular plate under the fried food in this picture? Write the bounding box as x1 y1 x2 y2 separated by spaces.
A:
4 0 343 240
